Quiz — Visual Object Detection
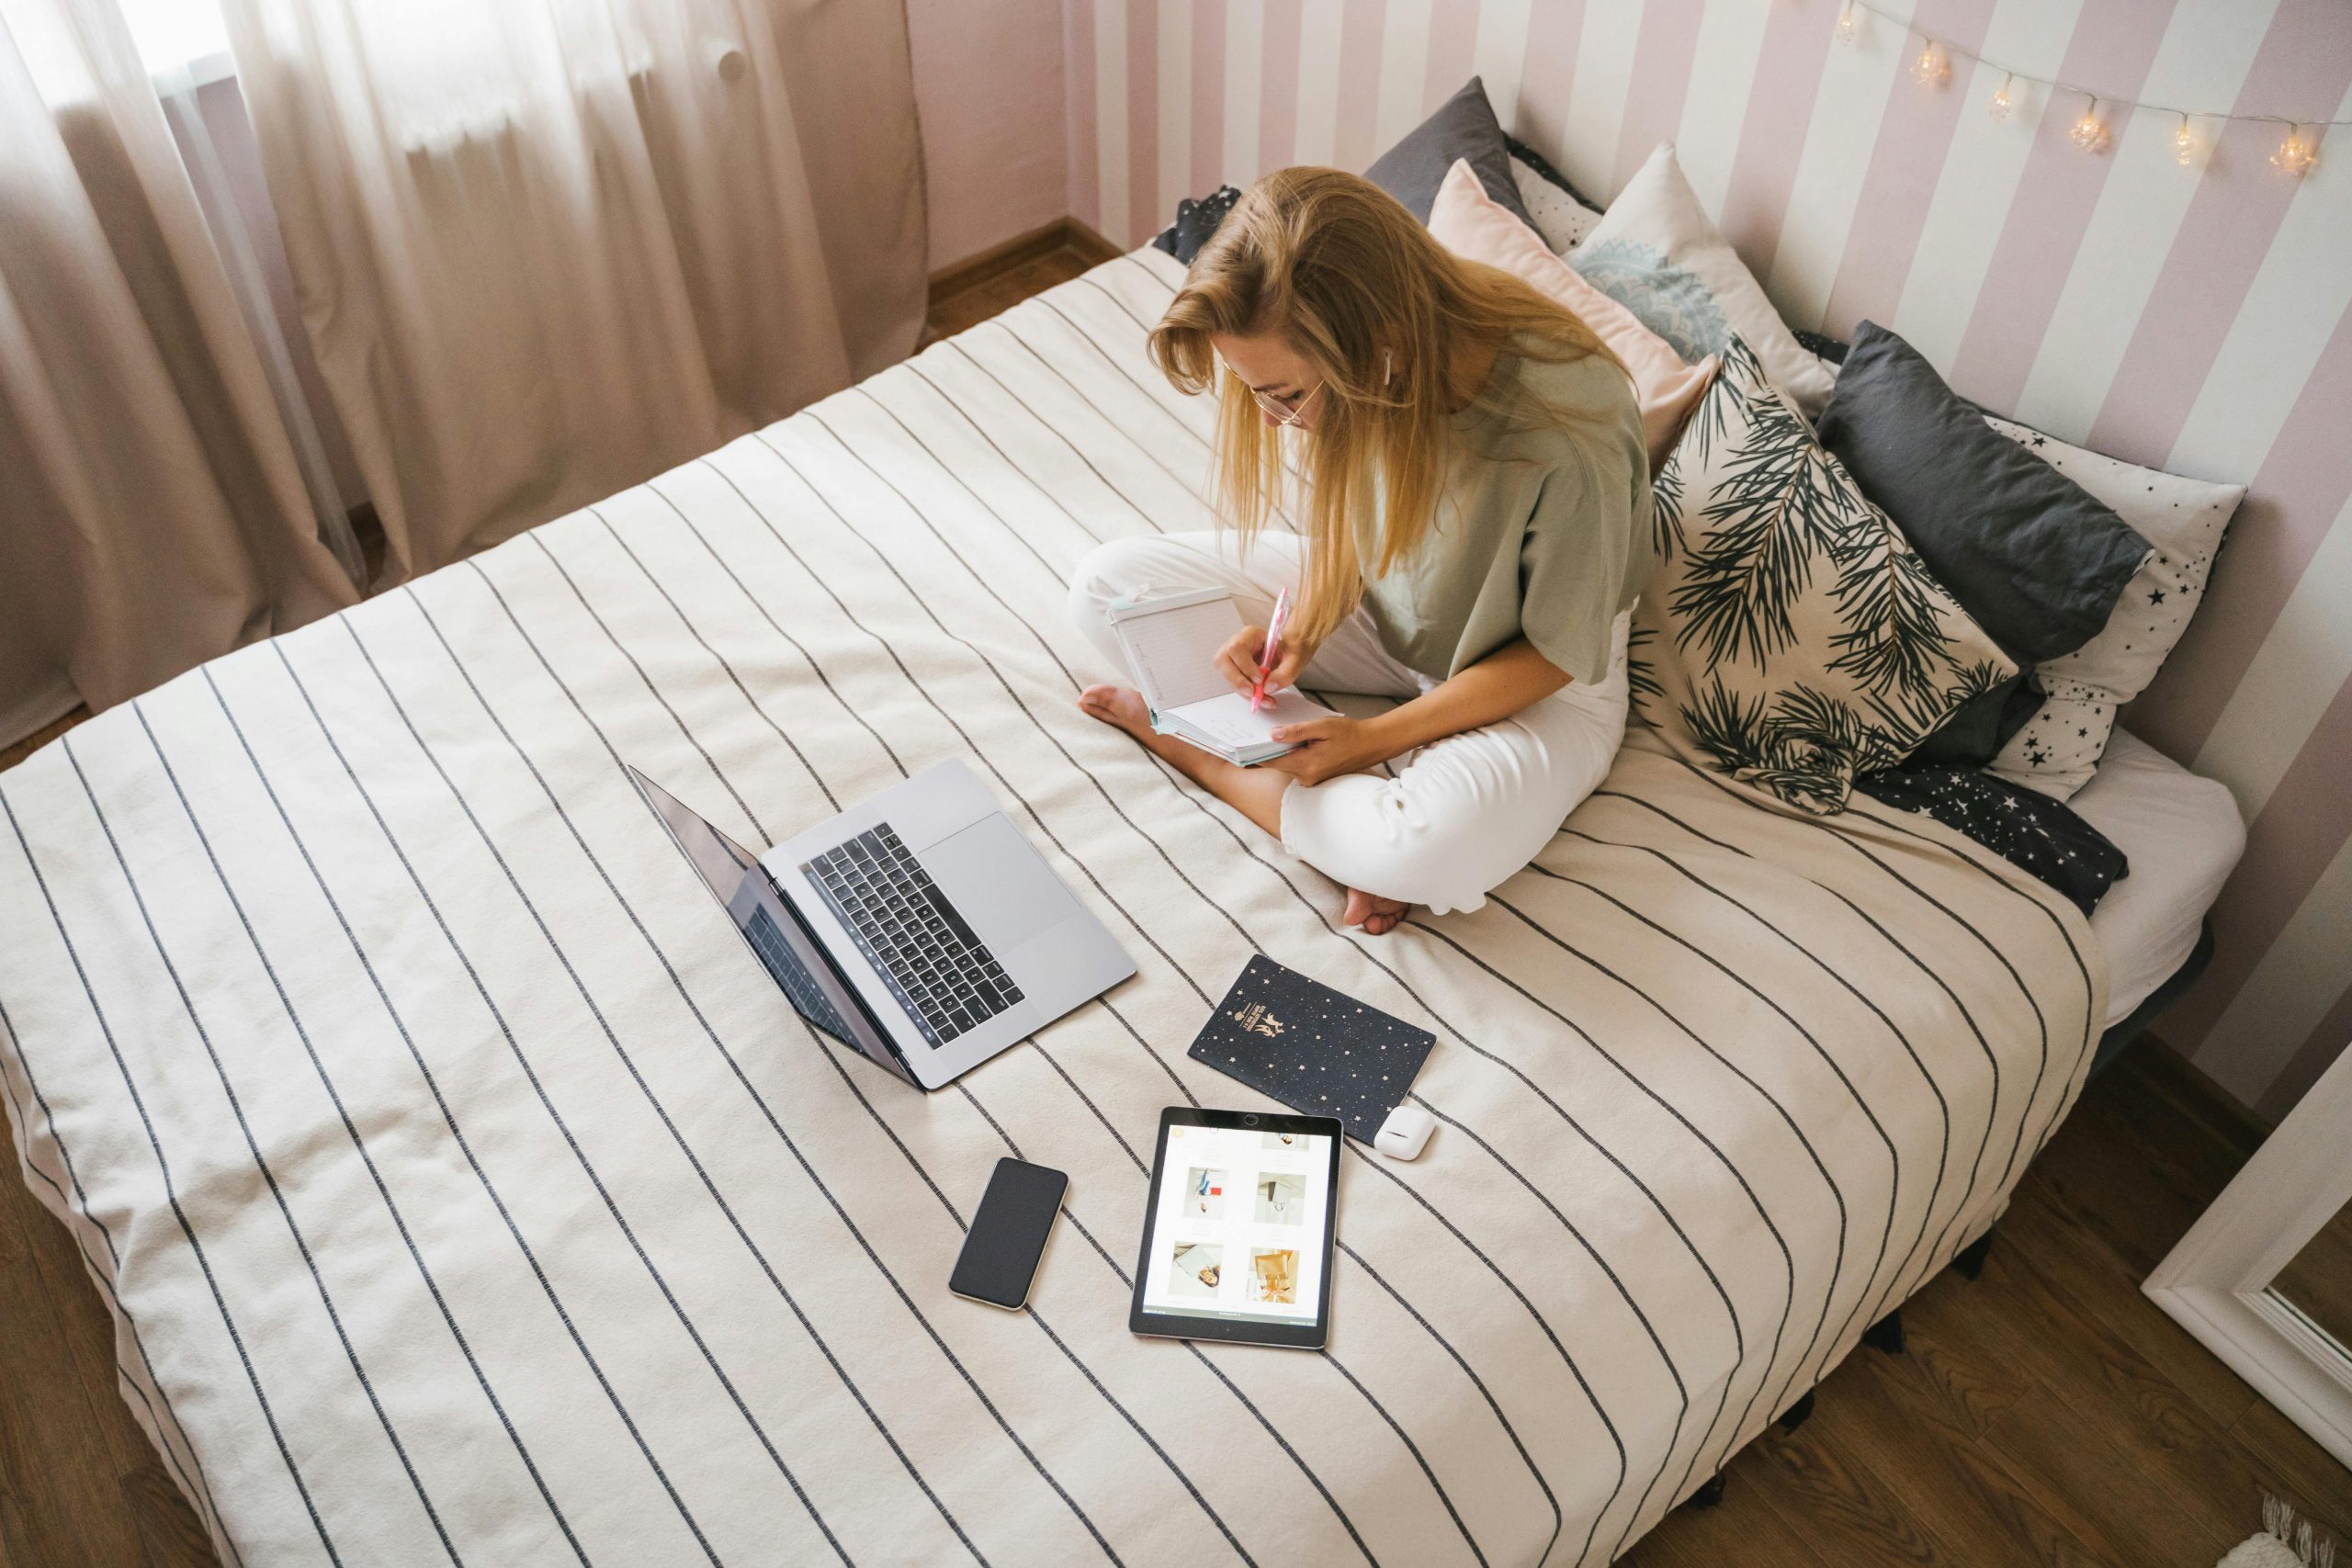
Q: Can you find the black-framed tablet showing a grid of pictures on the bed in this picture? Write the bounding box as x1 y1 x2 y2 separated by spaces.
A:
1126 1105 1343 1349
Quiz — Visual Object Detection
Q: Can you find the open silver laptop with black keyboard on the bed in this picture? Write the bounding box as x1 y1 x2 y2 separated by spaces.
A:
623 760 1136 1089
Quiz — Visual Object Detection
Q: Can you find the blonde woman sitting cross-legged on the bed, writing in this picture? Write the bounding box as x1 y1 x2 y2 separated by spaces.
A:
1070 169 1651 936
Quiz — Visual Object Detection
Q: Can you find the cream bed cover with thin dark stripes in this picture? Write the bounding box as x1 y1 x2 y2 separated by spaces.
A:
0 252 2105 1568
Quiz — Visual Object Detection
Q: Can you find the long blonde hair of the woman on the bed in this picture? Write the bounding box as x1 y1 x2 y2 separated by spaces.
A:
1148 167 1623 647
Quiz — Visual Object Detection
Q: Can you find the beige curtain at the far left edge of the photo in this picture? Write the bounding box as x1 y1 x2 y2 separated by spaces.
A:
0 0 356 743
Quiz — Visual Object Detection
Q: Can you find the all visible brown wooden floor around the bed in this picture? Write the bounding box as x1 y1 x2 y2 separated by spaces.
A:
0 223 2352 1568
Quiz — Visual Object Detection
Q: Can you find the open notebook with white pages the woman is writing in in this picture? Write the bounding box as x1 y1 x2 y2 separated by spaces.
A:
1108 588 1331 766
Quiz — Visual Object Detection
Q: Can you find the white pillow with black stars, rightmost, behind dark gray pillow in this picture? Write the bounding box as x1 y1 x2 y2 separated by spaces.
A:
1985 416 2246 799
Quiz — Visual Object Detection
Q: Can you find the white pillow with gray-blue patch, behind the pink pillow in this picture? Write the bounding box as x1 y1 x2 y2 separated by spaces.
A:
1569 141 1830 419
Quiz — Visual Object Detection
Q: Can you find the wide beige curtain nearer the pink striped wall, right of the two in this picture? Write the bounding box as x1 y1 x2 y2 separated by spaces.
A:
223 0 924 581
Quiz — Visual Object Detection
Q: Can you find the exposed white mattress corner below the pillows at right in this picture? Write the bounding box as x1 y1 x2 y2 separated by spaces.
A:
2067 728 2246 1022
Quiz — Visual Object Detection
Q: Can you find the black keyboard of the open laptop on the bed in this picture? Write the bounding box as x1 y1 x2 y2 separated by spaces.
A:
799 823 1021 1046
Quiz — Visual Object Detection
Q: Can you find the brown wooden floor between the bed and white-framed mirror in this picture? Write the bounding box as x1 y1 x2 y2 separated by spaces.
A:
1628 1039 2352 1568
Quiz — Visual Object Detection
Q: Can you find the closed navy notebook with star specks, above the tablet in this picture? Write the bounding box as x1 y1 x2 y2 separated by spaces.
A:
1190 954 1437 1143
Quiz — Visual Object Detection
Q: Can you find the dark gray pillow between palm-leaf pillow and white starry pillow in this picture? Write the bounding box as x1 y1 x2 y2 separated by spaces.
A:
1820 322 2147 663
